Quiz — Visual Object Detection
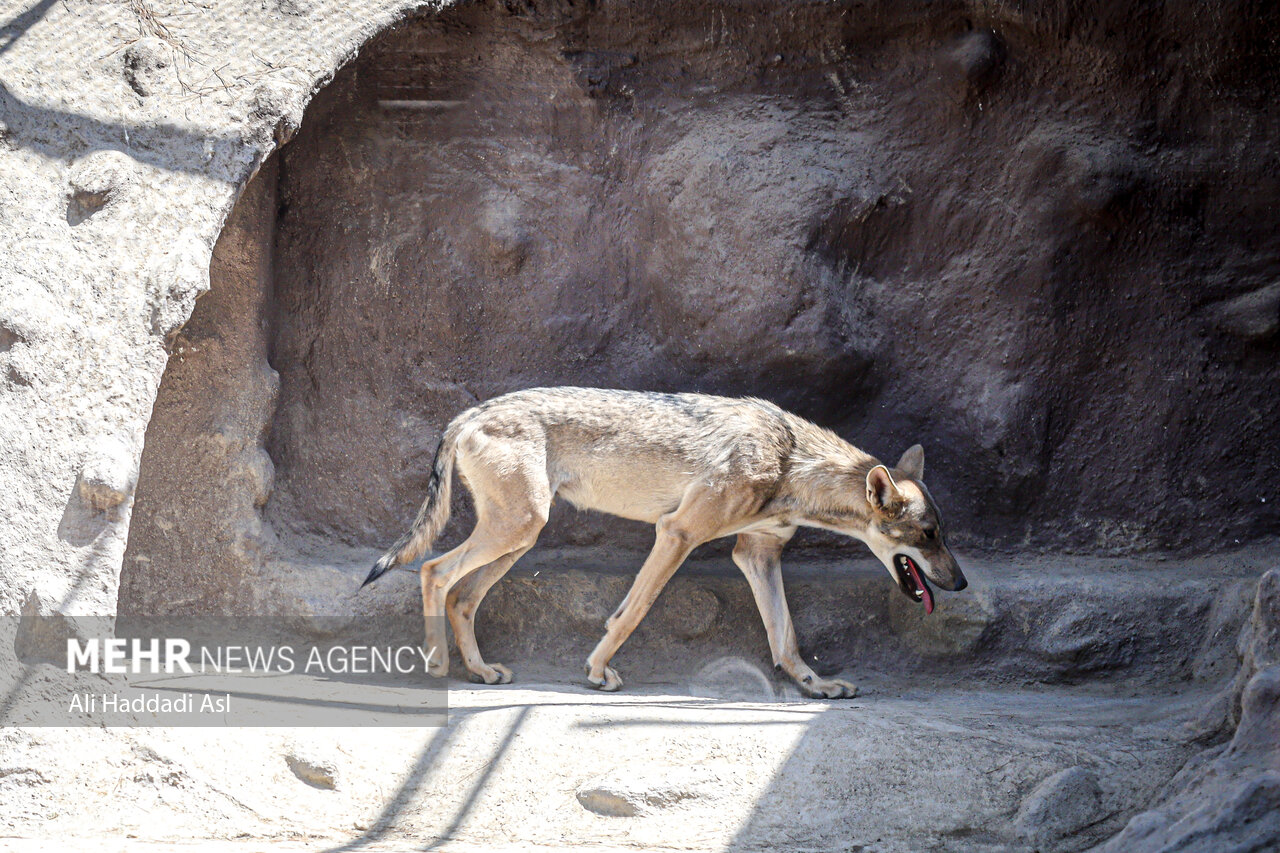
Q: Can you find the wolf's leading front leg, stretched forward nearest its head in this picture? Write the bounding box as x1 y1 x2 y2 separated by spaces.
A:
733 533 858 699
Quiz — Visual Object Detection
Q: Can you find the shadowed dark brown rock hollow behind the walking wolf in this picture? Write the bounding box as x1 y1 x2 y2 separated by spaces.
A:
119 3 1280 660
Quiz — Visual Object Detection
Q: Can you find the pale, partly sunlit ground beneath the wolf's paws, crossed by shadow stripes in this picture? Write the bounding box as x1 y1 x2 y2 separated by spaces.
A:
0 661 1206 853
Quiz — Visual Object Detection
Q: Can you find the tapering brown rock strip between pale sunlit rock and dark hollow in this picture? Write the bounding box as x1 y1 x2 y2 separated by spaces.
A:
118 159 279 622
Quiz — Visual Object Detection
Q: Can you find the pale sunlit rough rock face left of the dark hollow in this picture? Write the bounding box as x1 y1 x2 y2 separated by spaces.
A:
0 0 408 655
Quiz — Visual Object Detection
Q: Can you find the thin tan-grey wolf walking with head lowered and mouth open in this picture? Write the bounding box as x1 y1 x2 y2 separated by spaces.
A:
365 388 966 698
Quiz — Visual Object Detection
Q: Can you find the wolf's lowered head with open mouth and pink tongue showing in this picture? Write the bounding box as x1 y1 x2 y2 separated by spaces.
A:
864 444 969 613
